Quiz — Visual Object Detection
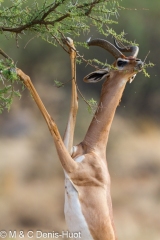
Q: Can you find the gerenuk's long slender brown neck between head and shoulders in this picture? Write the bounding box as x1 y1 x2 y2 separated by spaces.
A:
83 71 128 153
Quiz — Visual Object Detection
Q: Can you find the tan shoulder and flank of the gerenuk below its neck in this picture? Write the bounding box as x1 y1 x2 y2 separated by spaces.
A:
69 149 116 240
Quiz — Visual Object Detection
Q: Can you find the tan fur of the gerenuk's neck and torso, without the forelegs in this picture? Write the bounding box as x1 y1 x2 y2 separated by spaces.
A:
66 60 142 240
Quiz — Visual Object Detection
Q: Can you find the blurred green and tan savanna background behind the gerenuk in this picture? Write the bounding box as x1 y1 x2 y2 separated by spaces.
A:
0 0 160 240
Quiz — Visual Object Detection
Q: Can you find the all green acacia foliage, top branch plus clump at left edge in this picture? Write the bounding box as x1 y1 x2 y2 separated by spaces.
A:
0 0 152 113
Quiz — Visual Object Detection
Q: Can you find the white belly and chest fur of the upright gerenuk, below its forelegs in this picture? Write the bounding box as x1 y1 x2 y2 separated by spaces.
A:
64 156 93 240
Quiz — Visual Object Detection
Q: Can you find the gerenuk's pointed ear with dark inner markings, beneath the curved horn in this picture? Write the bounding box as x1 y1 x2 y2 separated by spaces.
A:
83 68 109 83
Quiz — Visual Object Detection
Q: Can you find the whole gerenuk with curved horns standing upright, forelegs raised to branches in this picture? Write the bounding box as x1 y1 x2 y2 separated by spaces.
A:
5 38 143 240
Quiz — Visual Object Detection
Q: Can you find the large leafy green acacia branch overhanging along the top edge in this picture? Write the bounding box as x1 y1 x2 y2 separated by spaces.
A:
0 0 122 42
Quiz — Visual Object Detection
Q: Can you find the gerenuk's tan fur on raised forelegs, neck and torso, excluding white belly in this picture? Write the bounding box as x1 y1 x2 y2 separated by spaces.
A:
17 38 143 240
